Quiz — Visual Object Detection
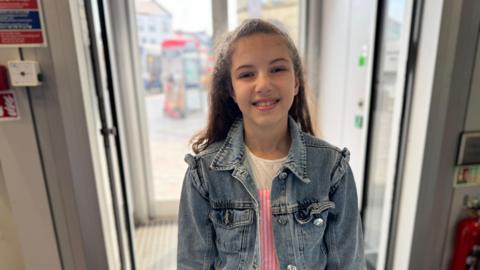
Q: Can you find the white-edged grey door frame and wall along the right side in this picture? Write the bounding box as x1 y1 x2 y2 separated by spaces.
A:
393 0 480 270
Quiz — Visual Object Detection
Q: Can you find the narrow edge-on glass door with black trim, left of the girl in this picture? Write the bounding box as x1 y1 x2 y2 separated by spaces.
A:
82 0 135 269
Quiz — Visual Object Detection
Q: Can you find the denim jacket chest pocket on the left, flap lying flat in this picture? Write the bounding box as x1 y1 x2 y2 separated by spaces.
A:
209 208 254 253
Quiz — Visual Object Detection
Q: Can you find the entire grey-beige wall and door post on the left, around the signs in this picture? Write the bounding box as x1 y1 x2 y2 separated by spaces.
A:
0 0 119 270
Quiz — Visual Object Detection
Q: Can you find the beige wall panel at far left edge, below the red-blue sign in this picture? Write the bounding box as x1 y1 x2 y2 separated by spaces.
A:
0 49 61 270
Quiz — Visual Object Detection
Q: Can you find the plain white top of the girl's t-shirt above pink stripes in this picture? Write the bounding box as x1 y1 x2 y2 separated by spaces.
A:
245 145 287 189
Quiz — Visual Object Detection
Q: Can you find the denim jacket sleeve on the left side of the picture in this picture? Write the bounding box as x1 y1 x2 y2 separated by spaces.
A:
177 155 216 270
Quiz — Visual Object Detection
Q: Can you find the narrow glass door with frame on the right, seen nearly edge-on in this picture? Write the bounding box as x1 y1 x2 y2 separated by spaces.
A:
363 0 413 269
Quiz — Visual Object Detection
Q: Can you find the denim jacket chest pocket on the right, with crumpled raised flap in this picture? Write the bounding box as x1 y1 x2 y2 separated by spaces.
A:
294 201 335 254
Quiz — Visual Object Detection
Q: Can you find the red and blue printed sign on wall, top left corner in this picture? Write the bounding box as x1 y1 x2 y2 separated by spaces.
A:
0 0 47 48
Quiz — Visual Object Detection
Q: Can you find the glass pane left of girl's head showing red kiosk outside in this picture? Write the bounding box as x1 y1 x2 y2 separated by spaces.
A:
136 0 212 207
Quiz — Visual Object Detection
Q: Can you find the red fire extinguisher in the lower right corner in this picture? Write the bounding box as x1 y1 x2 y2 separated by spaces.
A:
450 203 480 270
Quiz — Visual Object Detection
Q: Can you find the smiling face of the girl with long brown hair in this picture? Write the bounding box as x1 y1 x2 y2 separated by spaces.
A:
230 34 298 129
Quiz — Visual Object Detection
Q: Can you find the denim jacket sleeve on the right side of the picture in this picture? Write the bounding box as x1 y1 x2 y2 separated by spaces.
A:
326 149 366 270
